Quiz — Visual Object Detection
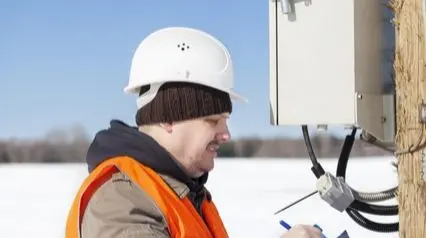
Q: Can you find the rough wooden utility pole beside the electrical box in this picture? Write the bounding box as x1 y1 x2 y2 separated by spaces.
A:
391 0 426 238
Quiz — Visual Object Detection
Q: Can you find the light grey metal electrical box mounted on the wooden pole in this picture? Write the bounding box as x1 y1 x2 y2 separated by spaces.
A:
269 0 395 141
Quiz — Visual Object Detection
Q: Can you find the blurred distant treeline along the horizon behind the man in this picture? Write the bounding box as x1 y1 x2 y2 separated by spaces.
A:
0 126 390 163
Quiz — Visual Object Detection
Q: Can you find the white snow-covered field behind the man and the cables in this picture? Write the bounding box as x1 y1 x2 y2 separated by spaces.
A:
0 157 398 238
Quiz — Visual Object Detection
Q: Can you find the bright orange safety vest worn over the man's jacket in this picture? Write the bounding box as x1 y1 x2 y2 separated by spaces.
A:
66 156 228 238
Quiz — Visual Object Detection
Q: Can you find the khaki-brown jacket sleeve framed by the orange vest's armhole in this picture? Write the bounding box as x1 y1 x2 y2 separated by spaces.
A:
81 173 170 238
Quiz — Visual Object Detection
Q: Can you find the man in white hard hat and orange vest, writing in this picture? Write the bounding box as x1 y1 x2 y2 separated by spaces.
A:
66 27 320 238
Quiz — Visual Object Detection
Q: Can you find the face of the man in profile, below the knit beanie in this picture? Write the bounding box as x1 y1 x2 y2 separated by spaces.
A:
172 113 231 177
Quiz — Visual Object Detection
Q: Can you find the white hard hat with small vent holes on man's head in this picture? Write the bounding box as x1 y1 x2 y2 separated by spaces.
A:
124 27 247 108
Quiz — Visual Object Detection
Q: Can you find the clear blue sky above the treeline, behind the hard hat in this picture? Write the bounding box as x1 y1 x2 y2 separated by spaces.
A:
0 0 344 138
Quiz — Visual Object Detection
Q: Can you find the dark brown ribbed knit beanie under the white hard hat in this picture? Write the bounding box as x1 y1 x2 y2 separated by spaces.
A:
136 82 232 126
